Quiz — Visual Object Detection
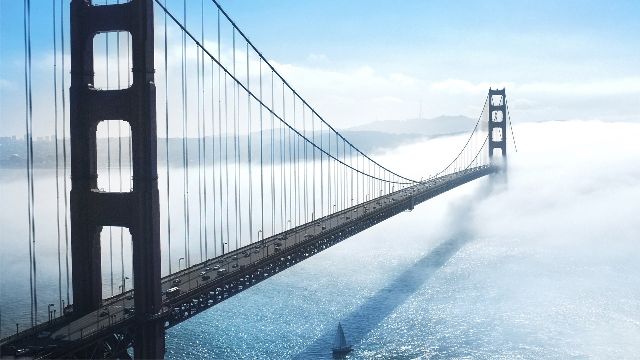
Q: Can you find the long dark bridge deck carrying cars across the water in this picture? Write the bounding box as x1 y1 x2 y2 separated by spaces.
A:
0 166 496 358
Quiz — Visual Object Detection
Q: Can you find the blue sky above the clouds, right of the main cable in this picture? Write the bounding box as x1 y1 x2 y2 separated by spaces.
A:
218 0 640 81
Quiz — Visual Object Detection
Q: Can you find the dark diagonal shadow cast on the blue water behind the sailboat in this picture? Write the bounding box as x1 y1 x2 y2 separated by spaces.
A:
294 215 471 359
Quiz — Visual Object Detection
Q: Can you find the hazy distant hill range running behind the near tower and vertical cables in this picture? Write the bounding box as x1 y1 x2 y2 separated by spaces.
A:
0 116 476 168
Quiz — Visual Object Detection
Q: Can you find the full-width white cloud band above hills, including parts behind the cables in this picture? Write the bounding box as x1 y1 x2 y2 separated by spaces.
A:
0 28 640 139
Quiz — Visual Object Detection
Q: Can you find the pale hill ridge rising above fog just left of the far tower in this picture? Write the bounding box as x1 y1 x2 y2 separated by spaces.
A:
348 115 477 137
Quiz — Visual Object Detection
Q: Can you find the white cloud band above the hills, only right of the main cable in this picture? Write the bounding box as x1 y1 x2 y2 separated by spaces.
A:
251 63 640 127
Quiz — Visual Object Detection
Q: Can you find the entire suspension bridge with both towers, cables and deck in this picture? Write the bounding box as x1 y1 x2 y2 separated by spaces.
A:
0 0 510 358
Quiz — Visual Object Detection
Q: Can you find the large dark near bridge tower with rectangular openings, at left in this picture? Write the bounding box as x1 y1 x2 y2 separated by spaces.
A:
70 0 164 358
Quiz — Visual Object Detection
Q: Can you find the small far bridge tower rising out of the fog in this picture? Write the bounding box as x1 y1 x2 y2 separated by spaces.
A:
489 88 507 163
